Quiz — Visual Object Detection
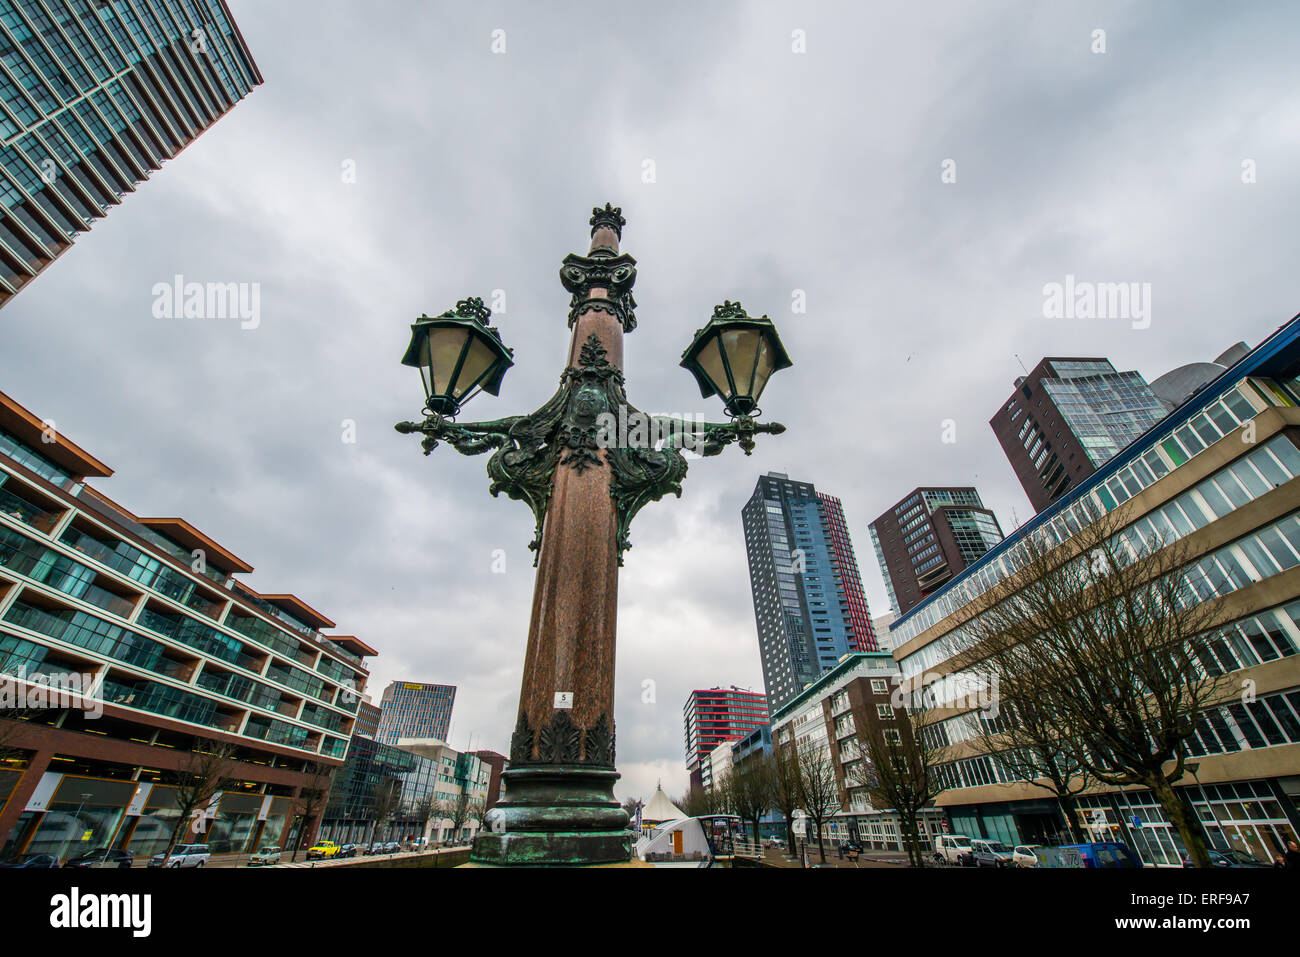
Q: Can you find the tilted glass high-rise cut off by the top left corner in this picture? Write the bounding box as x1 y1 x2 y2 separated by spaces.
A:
0 0 261 306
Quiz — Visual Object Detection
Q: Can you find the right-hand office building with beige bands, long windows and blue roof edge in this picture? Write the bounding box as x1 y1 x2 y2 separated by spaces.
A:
891 310 1300 866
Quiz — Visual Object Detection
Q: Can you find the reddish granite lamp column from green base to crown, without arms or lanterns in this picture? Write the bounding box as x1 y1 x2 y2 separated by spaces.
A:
473 209 636 863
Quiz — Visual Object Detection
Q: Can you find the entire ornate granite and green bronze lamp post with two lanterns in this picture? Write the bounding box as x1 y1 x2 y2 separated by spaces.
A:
397 204 790 865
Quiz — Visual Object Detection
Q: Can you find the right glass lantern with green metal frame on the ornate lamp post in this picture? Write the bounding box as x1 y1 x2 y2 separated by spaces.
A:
681 303 793 415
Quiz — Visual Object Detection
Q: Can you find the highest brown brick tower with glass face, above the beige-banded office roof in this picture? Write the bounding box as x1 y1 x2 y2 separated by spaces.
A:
989 358 1167 510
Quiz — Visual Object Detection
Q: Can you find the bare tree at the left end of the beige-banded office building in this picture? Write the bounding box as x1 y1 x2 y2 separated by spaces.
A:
850 693 949 867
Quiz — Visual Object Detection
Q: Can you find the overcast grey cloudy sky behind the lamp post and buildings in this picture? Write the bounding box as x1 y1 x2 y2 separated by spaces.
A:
0 0 1300 798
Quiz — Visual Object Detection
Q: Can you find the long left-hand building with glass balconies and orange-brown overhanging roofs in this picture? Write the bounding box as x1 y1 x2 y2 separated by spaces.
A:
0 393 374 858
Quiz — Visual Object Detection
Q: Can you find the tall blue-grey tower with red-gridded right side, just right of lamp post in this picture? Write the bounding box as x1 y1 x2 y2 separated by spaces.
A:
741 472 878 709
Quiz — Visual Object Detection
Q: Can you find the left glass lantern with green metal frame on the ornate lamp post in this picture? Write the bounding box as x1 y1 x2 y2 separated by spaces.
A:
402 302 515 416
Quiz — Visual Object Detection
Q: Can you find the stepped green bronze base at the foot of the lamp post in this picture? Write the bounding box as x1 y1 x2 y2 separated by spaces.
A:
469 765 633 867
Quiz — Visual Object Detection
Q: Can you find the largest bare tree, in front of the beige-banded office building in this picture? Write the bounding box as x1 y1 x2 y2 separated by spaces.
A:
963 501 1240 867
